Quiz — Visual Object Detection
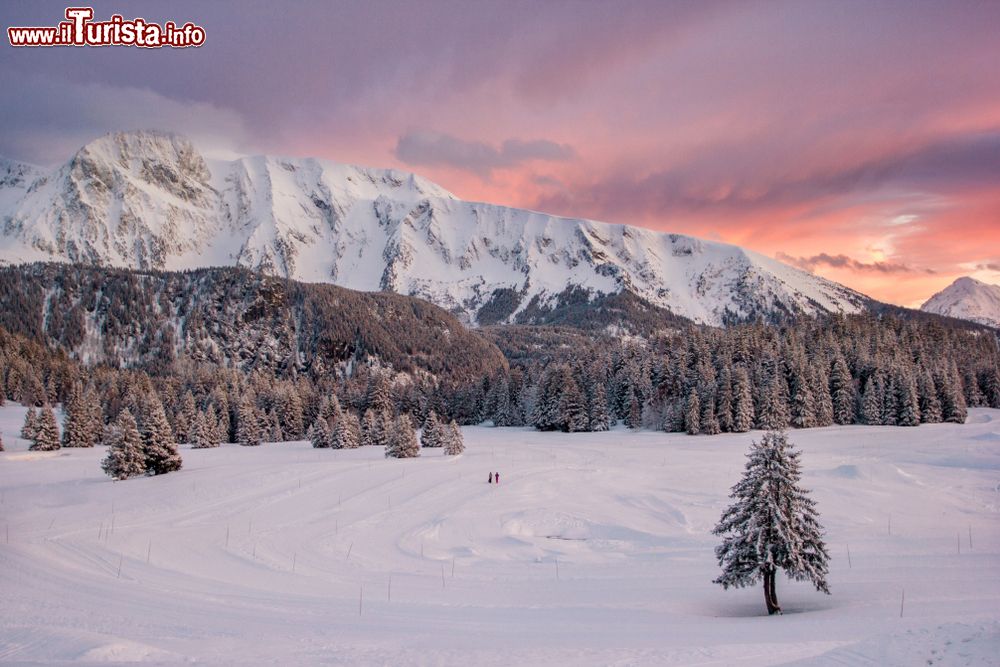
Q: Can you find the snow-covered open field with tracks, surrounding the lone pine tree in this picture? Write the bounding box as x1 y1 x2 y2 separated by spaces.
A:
0 404 1000 667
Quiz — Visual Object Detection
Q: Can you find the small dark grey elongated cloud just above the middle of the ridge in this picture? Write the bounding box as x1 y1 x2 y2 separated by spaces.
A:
396 132 576 178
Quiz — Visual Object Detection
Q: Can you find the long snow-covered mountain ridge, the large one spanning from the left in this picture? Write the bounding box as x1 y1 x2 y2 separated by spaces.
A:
0 132 869 324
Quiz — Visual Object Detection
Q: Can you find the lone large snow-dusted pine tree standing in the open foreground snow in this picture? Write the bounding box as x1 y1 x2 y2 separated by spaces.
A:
712 432 830 614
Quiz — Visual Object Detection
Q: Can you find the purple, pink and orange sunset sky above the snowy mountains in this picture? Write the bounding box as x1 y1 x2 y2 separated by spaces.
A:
0 0 1000 305
